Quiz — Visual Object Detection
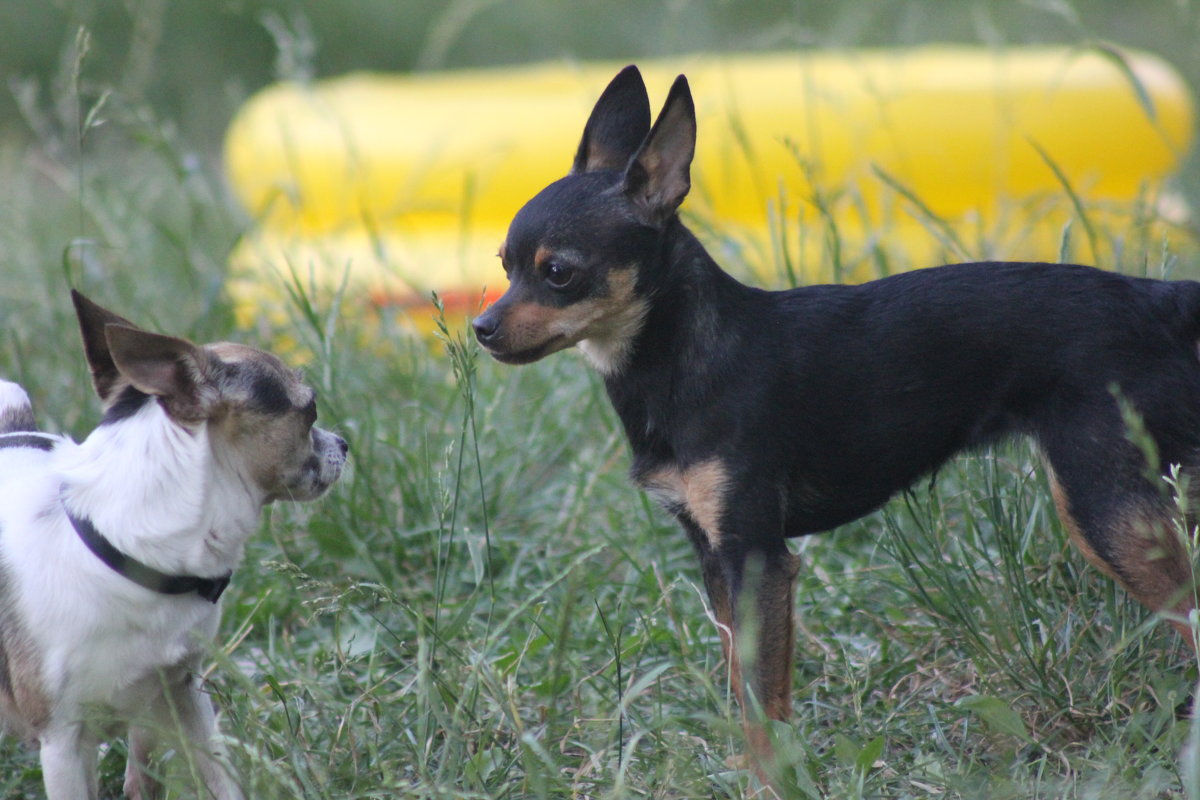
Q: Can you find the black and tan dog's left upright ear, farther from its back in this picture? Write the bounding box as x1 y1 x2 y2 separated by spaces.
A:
571 65 650 173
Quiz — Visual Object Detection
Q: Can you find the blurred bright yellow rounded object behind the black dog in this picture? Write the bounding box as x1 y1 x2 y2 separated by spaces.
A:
226 47 1193 321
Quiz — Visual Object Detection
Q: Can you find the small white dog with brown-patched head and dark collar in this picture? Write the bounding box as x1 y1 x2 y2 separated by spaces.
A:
0 293 347 800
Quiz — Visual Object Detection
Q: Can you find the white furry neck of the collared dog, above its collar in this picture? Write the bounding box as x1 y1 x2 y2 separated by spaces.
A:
59 398 263 577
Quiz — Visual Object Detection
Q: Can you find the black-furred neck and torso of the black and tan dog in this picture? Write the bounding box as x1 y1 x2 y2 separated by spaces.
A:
624 248 1200 540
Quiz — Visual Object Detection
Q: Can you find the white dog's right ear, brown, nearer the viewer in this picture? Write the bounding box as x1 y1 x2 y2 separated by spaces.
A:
104 324 208 421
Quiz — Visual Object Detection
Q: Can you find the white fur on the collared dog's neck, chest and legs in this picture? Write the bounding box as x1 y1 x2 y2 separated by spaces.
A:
0 402 263 800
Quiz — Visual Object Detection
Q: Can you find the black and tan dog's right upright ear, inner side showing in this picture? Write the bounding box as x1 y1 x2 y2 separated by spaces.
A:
625 76 696 225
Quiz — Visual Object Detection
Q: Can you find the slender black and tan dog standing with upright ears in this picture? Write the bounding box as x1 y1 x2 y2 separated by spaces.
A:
474 67 1200 777
